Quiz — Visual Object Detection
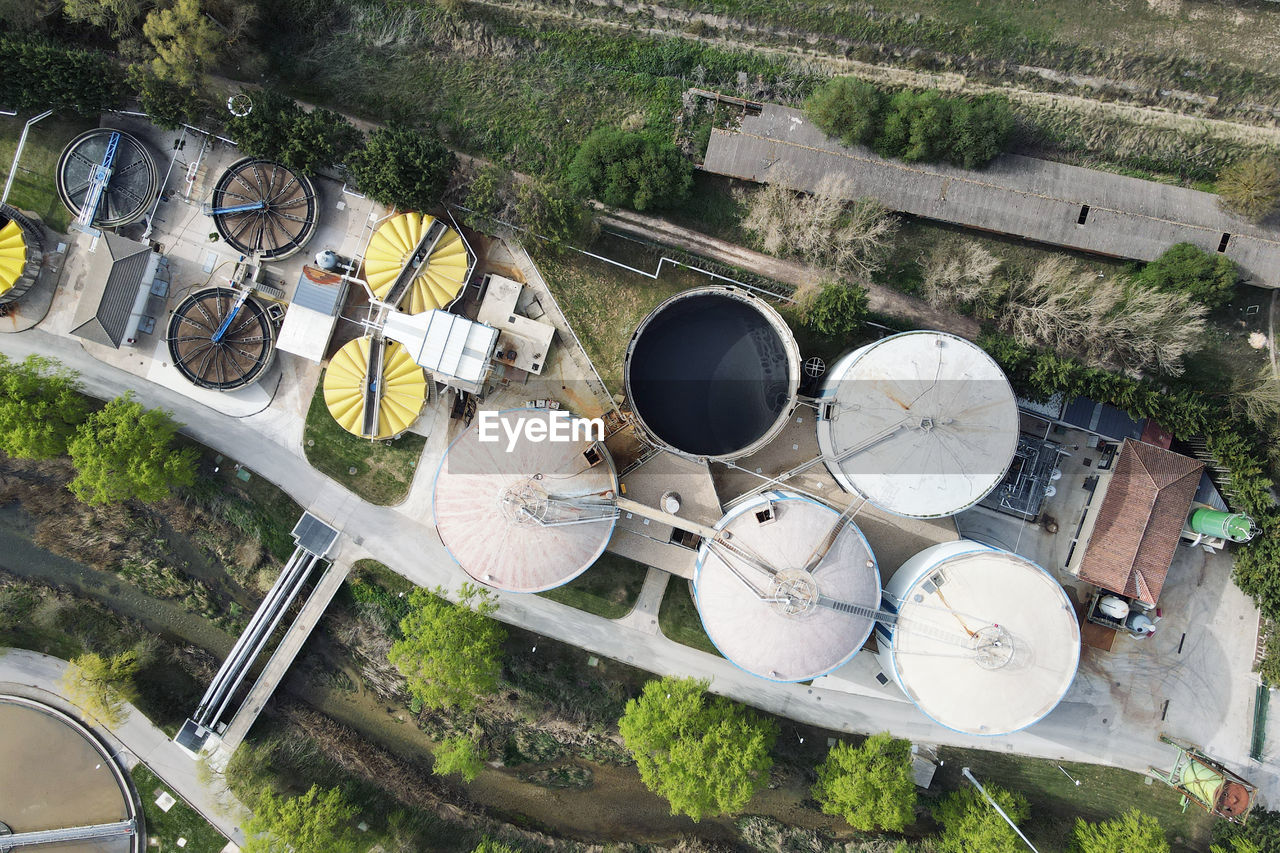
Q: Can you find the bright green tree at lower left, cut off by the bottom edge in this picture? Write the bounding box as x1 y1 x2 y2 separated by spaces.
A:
244 785 358 853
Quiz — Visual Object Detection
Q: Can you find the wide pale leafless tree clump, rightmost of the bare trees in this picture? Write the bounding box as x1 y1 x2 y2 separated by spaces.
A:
996 257 1206 375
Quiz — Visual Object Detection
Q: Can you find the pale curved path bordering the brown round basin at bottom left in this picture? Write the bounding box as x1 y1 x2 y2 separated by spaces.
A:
0 648 248 849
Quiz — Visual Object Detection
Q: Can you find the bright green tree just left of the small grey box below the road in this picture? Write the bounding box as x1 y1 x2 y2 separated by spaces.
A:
813 731 915 833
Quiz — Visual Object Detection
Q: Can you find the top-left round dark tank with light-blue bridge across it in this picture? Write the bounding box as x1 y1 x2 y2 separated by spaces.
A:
55 128 160 228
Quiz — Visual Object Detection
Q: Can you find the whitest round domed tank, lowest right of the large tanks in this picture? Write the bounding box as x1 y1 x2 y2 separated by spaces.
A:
876 539 1080 735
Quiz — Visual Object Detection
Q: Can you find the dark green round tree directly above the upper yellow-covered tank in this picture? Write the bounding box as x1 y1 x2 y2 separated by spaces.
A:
347 124 456 210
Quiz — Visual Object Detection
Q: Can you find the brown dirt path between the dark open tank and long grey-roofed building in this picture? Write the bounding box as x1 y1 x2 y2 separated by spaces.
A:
596 210 979 339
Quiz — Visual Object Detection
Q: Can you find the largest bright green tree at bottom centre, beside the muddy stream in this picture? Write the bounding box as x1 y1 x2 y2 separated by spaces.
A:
618 676 777 821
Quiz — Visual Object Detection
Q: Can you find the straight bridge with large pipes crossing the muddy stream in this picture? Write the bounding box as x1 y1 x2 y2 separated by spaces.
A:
174 512 349 753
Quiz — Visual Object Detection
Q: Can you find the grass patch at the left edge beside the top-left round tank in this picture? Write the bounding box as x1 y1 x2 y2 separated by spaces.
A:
0 115 97 233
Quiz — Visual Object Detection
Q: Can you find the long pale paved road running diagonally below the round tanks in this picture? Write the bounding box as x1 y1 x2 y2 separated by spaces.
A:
0 329 1203 794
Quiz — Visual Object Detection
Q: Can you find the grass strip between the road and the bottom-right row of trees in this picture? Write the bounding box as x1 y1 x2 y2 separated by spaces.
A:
933 747 1215 853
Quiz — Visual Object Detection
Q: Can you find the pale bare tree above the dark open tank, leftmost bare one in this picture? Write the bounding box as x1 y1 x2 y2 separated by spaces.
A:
742 183 897 280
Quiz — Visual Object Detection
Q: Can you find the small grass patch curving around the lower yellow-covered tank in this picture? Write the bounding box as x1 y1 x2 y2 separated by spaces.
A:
302 383 426 506
